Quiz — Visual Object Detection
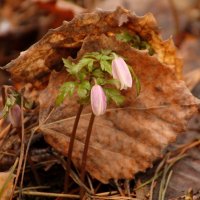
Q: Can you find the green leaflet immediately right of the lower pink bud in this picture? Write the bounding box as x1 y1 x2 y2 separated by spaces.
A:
104 88 125 106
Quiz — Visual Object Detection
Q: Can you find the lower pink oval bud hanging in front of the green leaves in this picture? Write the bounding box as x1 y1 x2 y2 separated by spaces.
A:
90 85 107 116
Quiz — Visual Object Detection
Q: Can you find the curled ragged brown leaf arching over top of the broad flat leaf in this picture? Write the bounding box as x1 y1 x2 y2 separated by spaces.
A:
2 8 182 87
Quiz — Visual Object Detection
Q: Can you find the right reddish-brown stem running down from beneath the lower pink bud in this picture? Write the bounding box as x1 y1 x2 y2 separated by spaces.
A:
80 113 95 199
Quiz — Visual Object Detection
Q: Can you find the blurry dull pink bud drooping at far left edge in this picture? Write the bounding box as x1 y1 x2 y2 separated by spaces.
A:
8 104 21 128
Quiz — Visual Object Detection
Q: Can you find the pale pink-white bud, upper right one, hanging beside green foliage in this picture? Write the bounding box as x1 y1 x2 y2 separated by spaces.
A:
112 57 132 90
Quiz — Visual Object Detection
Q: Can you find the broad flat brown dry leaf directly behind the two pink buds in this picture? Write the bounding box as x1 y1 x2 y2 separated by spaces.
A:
40 35 198 183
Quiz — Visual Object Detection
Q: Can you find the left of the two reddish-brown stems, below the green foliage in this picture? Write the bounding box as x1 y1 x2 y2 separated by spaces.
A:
64 105 83 193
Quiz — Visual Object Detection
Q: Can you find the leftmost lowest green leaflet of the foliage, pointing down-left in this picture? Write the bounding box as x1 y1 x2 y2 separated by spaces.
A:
56 82 76 106
